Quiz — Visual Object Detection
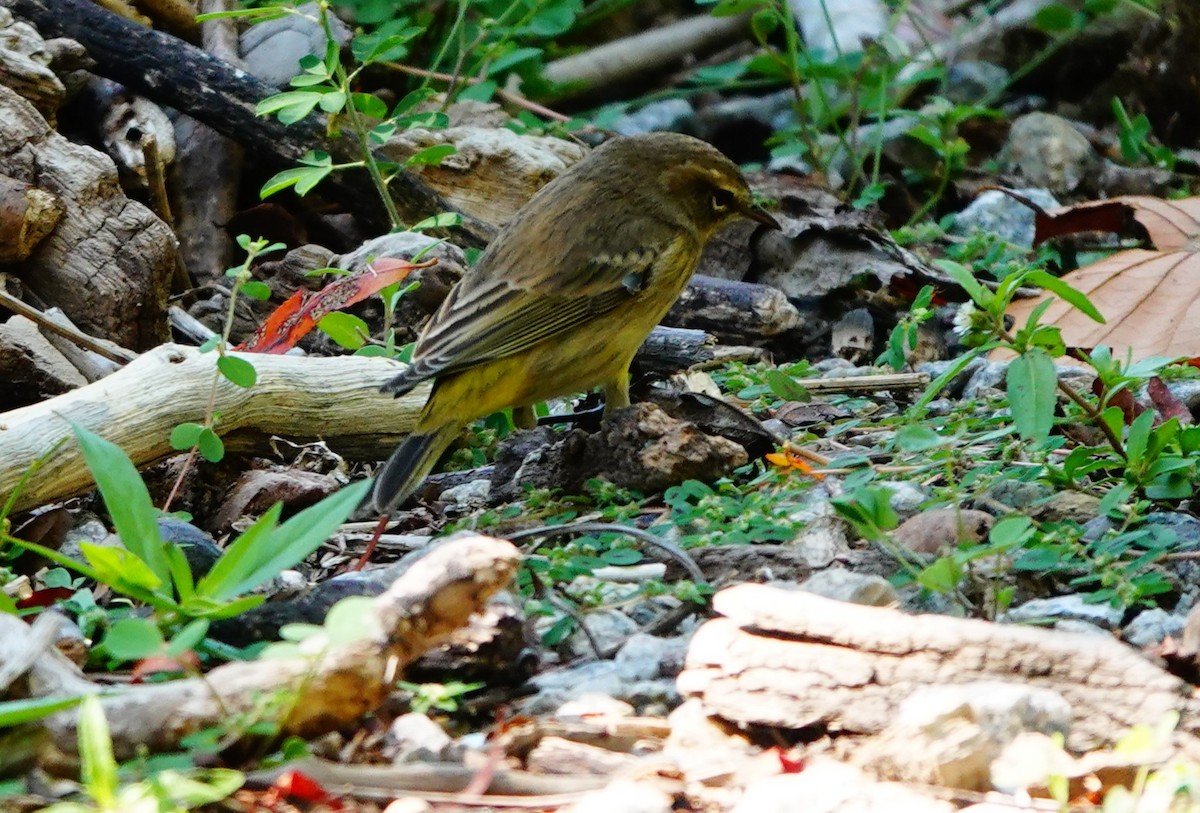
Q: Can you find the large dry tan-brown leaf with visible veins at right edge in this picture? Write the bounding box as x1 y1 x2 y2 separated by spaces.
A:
1008 197 1200 359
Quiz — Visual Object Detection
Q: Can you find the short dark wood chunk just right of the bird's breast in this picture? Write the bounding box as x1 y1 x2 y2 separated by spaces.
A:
662 273 800 344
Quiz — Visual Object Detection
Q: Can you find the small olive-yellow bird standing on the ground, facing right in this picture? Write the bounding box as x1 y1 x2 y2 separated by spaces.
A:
372 132 780 514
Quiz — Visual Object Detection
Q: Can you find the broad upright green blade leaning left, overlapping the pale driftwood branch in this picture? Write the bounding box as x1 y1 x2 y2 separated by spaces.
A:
71 423 170 584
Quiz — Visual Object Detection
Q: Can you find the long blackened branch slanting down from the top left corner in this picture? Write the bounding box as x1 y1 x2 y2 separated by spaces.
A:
0 0 491 246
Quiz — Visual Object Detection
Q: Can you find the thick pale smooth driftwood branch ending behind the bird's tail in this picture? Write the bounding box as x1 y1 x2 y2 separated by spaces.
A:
0 344 428 511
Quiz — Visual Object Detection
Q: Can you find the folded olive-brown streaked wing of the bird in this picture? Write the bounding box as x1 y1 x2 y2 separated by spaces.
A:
384 246 679 395
